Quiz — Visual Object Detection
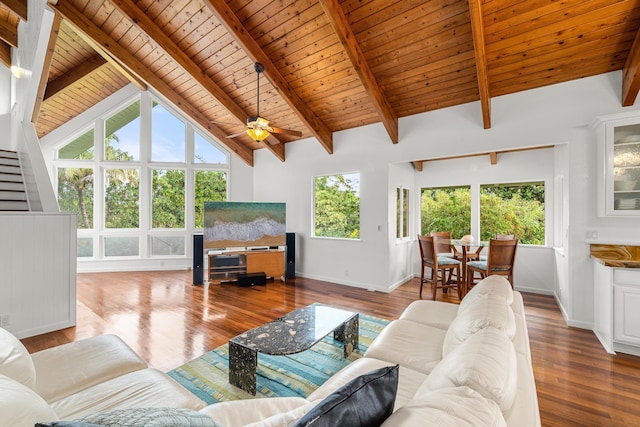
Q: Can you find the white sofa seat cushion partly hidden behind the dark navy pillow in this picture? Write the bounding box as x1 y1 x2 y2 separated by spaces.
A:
307 357 427 409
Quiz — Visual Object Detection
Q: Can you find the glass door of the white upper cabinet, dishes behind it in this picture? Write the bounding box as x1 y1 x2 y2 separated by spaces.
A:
608 124 640 215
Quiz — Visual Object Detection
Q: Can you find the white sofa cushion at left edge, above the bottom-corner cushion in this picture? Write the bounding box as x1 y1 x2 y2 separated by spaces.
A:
0 328 36 388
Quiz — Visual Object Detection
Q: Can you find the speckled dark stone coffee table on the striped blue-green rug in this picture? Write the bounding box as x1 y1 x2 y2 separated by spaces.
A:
229 304 360 396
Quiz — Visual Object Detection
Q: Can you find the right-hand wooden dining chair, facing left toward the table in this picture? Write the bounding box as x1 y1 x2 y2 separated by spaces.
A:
465 239 518 290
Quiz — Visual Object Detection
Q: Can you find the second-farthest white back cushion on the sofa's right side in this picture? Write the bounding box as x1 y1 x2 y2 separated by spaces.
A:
442 295 516 357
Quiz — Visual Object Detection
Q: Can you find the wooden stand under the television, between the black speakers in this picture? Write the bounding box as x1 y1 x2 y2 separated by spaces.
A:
208 249 285 283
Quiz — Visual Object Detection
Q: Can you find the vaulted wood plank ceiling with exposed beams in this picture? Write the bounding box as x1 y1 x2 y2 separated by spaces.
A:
0 0 640 165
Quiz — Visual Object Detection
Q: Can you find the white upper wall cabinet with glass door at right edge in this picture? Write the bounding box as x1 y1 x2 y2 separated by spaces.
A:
597 113 640 216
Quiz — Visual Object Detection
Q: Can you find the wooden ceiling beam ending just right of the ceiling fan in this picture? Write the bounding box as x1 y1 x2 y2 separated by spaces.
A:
204 0 333 154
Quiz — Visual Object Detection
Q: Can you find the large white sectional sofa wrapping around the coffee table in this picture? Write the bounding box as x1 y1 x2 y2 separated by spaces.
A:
0 276 540 427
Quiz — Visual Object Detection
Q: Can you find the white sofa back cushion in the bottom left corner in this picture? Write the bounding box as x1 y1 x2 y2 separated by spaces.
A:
0 375 58 426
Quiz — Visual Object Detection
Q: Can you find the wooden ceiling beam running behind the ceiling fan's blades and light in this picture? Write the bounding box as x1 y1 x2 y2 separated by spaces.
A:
111 0 285 162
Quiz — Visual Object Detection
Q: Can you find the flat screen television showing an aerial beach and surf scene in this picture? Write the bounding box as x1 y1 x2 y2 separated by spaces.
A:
204 202 287 249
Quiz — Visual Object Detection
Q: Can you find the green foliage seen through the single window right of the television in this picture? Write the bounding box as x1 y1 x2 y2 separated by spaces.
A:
315 174 360 239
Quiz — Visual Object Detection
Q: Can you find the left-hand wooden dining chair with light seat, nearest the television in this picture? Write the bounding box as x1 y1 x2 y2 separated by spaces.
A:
418 235 462 301
